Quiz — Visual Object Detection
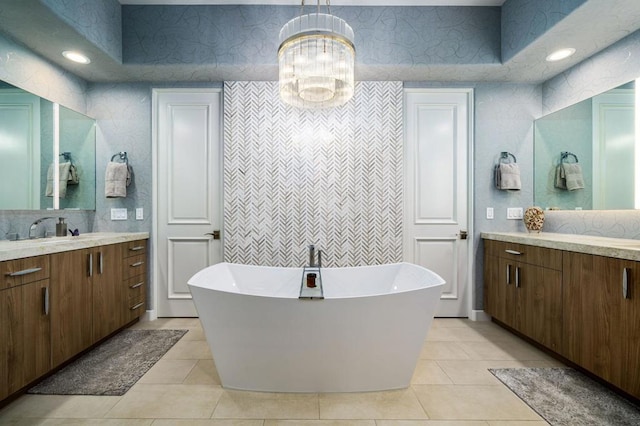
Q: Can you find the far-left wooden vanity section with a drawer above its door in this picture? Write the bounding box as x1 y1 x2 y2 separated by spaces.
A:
0 256 51 400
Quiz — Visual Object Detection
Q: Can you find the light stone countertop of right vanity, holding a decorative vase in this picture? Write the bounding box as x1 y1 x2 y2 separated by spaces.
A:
480 232 640 261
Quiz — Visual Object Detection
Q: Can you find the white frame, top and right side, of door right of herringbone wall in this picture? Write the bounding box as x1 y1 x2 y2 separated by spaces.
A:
403 88 472 321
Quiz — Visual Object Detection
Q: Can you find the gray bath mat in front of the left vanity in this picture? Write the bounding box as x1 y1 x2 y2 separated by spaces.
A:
28 329 188 395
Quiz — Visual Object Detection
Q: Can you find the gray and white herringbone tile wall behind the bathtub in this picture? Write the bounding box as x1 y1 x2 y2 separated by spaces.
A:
224 81 403 266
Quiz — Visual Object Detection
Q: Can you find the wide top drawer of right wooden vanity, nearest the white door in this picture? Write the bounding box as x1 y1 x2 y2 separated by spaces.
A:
484 240 562 270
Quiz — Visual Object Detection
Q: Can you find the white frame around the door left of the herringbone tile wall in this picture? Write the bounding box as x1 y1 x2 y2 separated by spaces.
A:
152 87 224 321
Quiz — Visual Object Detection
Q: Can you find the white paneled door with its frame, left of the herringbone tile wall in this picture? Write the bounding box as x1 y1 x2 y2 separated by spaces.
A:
153 89 222 317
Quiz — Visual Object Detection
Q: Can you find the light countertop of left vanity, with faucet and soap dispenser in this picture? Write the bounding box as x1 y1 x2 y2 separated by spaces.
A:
0 232 149 261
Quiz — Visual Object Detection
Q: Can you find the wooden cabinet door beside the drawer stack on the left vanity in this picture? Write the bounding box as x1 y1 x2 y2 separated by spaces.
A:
90 244 124 342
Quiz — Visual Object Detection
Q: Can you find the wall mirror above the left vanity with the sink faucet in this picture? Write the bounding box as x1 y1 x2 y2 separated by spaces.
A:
0 82 96 210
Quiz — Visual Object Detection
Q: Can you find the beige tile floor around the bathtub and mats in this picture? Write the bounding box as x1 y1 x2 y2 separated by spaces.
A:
0 318 559 426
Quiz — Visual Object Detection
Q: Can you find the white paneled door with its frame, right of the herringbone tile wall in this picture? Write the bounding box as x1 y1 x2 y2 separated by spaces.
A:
403 89 473 317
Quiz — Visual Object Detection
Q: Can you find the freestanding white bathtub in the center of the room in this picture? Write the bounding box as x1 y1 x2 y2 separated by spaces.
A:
189 263 444 392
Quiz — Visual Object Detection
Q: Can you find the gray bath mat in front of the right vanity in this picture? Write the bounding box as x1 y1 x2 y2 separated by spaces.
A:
489 368 640 426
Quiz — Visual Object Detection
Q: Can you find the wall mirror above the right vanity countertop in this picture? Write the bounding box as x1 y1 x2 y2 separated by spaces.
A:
534 82 640 210
